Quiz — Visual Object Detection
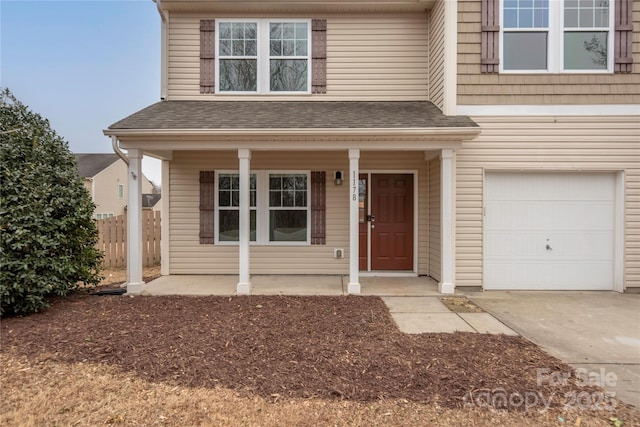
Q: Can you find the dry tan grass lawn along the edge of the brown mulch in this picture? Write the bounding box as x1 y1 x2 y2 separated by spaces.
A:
0 354 633 427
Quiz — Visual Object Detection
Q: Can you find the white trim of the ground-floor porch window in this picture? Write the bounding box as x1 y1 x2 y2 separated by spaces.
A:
213 169 311 246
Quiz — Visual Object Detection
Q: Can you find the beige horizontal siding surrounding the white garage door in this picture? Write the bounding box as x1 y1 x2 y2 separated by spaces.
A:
456 116 640 288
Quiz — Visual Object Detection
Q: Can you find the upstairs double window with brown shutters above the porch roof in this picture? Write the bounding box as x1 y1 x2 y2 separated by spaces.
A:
200 19 327 94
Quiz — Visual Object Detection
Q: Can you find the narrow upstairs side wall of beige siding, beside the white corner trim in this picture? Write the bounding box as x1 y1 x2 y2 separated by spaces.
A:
429 1 444 110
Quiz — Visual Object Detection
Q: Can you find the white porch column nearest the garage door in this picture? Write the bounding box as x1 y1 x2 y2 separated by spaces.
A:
438 149 456 294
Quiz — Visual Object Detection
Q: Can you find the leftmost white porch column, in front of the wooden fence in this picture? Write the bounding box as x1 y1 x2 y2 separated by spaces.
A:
127 148 144 294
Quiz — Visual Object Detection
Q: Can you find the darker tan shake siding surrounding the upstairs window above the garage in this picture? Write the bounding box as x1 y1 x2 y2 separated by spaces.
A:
457 0 640 105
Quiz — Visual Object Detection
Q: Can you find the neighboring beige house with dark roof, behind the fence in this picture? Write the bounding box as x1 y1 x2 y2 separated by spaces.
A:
75 153 160 219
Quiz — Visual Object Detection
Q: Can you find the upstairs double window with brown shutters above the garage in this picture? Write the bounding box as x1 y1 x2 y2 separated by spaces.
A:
481 0 633 73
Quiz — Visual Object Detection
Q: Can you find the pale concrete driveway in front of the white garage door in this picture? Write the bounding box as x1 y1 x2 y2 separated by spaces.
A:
466 291 640 408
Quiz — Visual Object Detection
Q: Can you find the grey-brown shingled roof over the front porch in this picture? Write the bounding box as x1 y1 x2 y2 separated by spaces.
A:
109 101 478 130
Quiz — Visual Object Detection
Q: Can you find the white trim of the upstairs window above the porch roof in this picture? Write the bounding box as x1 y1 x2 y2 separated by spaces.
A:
215 18 313 95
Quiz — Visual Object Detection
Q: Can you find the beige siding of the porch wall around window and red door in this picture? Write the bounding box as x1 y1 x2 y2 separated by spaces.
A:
169 151 428 274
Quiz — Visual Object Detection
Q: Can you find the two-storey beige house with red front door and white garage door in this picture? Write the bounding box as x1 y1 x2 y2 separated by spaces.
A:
105 0 640 293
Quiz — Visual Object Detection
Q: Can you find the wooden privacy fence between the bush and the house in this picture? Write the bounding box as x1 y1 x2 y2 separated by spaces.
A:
96 210 160 268
